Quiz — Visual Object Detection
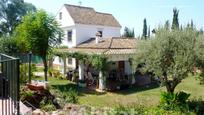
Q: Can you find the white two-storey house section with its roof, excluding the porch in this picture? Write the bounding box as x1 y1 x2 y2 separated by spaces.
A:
54 4 121 68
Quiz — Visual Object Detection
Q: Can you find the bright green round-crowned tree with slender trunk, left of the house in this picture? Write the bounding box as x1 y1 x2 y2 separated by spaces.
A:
15 10 62 81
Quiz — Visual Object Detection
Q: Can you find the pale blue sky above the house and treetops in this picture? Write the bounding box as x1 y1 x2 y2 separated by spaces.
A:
24 0 204 36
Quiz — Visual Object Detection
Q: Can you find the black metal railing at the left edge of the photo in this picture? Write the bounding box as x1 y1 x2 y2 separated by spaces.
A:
0 54 20 115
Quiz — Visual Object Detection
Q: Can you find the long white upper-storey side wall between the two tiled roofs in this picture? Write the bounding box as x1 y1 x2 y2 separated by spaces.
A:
76 24 121 45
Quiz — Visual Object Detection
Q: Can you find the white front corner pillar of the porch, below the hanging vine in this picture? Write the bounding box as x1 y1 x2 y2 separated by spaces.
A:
99 71 106 91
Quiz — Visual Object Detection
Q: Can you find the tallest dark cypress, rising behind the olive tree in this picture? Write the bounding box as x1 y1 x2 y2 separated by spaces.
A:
171 8 179 29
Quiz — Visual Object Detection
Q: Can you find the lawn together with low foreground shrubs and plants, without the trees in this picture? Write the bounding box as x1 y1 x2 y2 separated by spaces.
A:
19 68 204 115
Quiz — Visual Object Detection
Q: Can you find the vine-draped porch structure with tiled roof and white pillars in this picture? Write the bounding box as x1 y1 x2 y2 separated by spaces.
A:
55 38 136 91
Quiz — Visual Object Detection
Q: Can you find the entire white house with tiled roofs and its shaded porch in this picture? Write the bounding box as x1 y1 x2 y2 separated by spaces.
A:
54 4 144 91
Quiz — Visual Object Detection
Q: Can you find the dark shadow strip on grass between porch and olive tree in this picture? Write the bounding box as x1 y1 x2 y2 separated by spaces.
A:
114 83 159 95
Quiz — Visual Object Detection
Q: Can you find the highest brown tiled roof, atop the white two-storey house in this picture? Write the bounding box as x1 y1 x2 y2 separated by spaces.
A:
64 4 121 27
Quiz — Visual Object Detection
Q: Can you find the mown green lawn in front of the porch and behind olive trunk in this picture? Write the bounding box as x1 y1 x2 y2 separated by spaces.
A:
32 77 204 107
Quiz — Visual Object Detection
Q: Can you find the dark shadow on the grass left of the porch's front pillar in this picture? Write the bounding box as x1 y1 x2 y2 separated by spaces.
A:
51 83 105 96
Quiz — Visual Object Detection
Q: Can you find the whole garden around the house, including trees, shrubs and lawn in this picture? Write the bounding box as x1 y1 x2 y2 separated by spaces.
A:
0 0 204 115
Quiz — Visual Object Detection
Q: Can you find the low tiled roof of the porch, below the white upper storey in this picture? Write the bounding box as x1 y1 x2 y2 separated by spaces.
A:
57 37 137 55
